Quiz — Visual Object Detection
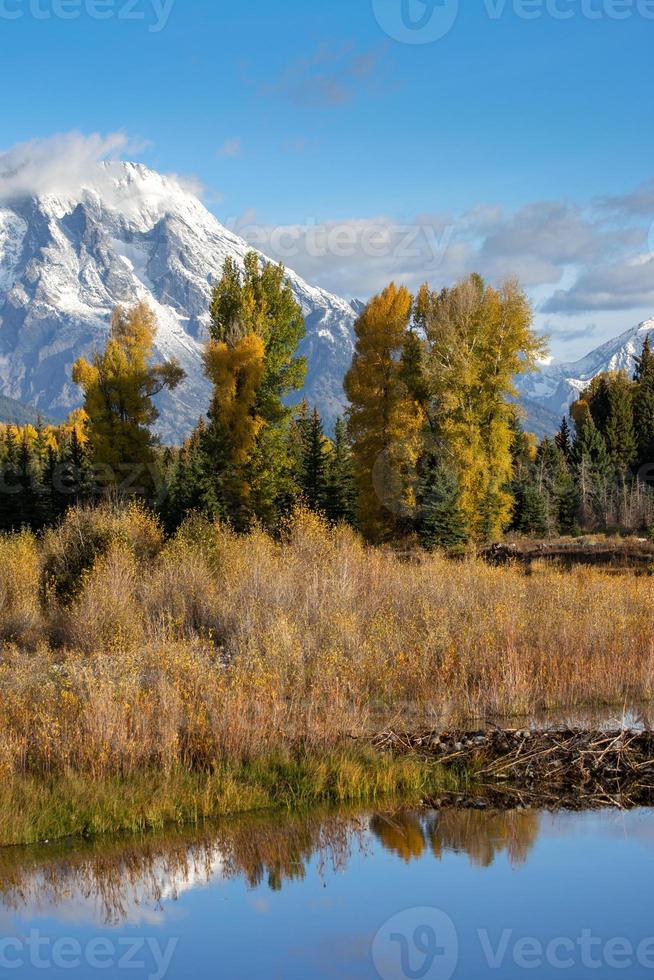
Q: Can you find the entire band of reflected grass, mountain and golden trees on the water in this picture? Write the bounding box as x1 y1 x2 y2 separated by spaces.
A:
0 810 540 925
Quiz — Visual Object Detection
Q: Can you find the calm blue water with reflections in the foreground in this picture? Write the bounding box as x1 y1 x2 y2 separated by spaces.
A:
0 810 654 980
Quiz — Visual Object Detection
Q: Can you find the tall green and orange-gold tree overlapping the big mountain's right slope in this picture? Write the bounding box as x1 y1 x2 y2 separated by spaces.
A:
204 252 306 528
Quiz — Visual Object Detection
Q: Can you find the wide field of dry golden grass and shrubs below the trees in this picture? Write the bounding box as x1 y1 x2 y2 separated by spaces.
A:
0 505 654 779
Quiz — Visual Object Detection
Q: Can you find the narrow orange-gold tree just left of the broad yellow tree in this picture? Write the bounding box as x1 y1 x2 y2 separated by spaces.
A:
345 283 424 541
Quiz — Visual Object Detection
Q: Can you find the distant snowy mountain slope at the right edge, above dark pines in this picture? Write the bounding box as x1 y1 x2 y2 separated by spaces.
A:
517 318 654 419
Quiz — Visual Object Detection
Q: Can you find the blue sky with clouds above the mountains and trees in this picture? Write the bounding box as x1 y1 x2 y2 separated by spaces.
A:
0 0 654 357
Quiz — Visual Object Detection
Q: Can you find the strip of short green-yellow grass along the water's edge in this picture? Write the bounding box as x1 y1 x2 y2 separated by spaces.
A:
0 749 466 845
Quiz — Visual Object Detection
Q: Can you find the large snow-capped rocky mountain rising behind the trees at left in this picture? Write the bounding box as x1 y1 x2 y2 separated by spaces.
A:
0 161 356 441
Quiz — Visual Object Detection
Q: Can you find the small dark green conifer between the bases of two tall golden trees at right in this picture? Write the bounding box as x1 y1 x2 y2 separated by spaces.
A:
416 455 469 551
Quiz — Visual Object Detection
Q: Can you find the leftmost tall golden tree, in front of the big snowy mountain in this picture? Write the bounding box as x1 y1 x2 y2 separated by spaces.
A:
73 303 184 493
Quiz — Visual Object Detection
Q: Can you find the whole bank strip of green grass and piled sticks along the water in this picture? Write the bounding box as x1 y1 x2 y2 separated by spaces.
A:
0 727 654 847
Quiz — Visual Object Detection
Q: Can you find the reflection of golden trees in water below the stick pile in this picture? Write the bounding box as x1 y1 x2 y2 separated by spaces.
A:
370 809 540 867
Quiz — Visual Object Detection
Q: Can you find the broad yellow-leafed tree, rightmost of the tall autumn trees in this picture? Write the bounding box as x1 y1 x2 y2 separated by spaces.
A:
416 275 545 540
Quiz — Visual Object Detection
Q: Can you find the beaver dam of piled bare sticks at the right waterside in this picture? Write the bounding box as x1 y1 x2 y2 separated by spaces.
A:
373 728 654 810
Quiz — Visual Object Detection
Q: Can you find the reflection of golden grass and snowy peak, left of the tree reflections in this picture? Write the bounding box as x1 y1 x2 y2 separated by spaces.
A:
0 814 364 923
